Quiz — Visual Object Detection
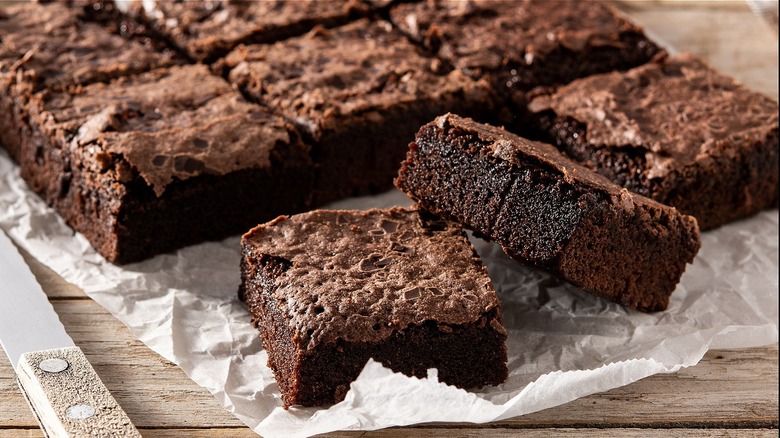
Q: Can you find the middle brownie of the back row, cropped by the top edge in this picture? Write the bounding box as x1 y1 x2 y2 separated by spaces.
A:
95 0 370 62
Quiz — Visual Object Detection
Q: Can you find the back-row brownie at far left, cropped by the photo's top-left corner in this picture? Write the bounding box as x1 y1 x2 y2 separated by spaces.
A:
0 3 172 159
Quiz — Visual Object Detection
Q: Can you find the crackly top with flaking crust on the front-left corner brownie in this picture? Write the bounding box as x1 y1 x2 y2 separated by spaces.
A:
39 65 302 196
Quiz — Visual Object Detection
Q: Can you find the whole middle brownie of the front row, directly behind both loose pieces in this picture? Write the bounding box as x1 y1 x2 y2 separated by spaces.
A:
224 19 494 204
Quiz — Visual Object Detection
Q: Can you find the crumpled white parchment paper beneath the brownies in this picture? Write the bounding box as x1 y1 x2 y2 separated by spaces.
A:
0 151 778 437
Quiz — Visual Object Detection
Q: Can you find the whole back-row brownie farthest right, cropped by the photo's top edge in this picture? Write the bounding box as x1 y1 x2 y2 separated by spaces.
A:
390 0 661 108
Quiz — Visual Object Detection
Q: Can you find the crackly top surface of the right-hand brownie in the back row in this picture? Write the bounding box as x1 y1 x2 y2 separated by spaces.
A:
390 0 641 74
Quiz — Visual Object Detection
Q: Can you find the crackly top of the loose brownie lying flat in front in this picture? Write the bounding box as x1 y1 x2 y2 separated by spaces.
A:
243 208 503 348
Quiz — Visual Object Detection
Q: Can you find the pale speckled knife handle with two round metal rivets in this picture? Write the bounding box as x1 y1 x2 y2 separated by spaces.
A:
17 347 141 437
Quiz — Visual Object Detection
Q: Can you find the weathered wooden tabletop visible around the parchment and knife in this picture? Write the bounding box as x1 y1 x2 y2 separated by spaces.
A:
0 1 778 438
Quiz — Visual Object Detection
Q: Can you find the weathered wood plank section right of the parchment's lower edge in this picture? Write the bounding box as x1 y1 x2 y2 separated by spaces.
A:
496 345 778 427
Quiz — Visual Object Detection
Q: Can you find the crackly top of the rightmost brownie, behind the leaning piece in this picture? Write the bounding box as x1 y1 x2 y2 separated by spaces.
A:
530 54 778 178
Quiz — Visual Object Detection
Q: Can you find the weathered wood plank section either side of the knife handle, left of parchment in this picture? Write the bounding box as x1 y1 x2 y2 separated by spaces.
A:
0 300 242 428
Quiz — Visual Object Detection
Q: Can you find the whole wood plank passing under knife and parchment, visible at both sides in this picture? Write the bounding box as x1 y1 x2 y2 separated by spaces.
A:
0 300 778 428
